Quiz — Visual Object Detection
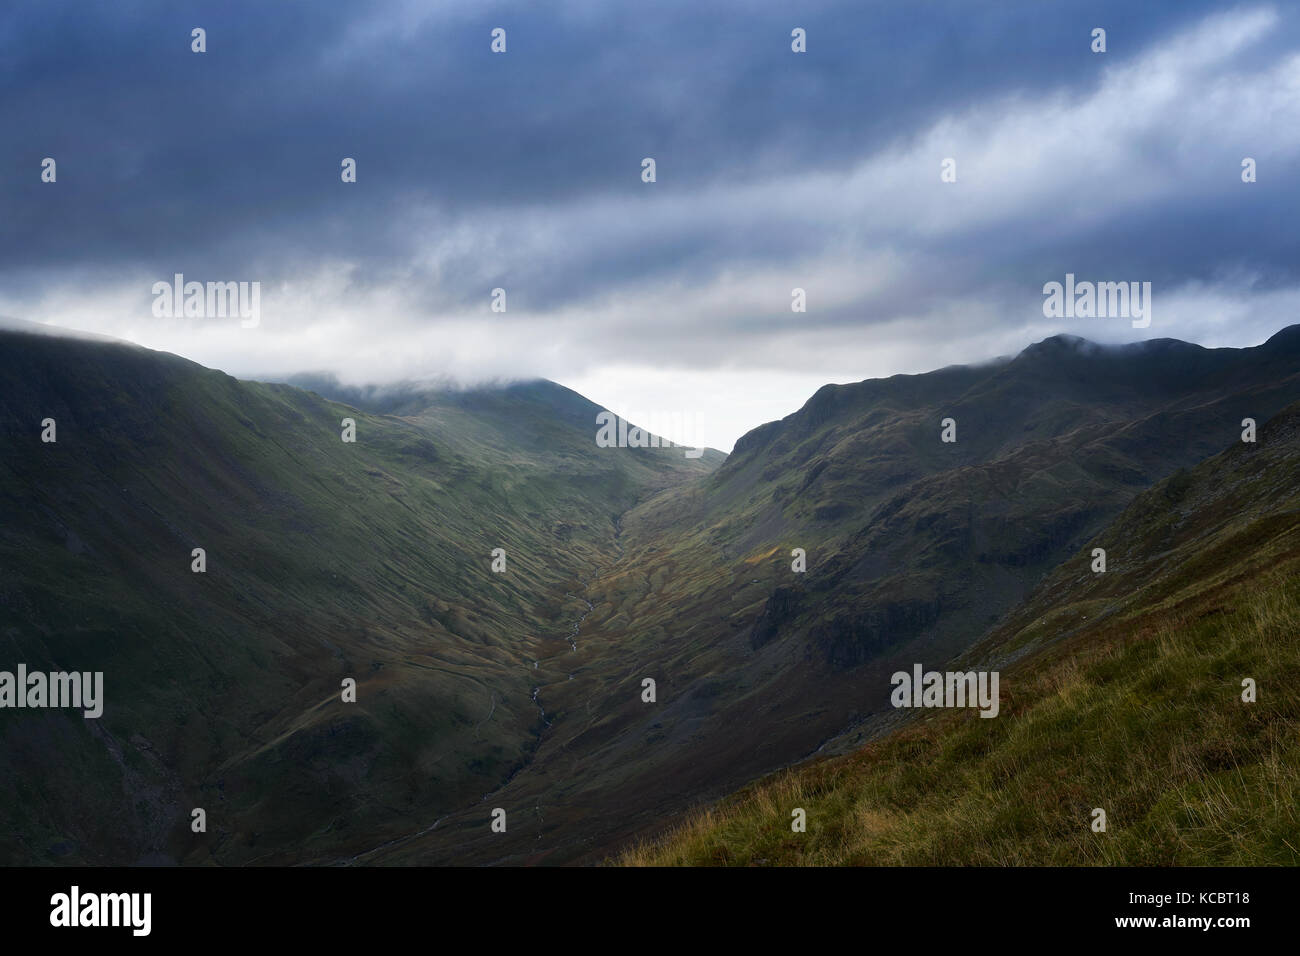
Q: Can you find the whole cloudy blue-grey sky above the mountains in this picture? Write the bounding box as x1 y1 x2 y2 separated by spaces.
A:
0 0 1300 450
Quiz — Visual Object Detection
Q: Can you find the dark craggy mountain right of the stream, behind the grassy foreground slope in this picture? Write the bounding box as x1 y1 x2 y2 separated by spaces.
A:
353 326 1300 862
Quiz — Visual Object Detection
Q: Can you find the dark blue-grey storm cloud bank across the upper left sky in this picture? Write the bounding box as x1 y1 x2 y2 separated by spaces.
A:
0 0 1237 280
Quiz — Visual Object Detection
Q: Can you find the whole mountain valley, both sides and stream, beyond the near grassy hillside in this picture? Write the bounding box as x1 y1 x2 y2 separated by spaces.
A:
0 326 1300 865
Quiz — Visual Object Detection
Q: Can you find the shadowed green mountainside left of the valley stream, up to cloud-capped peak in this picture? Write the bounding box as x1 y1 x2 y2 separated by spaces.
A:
0 333 710 864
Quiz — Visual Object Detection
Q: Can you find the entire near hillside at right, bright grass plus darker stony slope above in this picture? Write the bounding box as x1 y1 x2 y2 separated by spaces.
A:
619 407 1300 865
